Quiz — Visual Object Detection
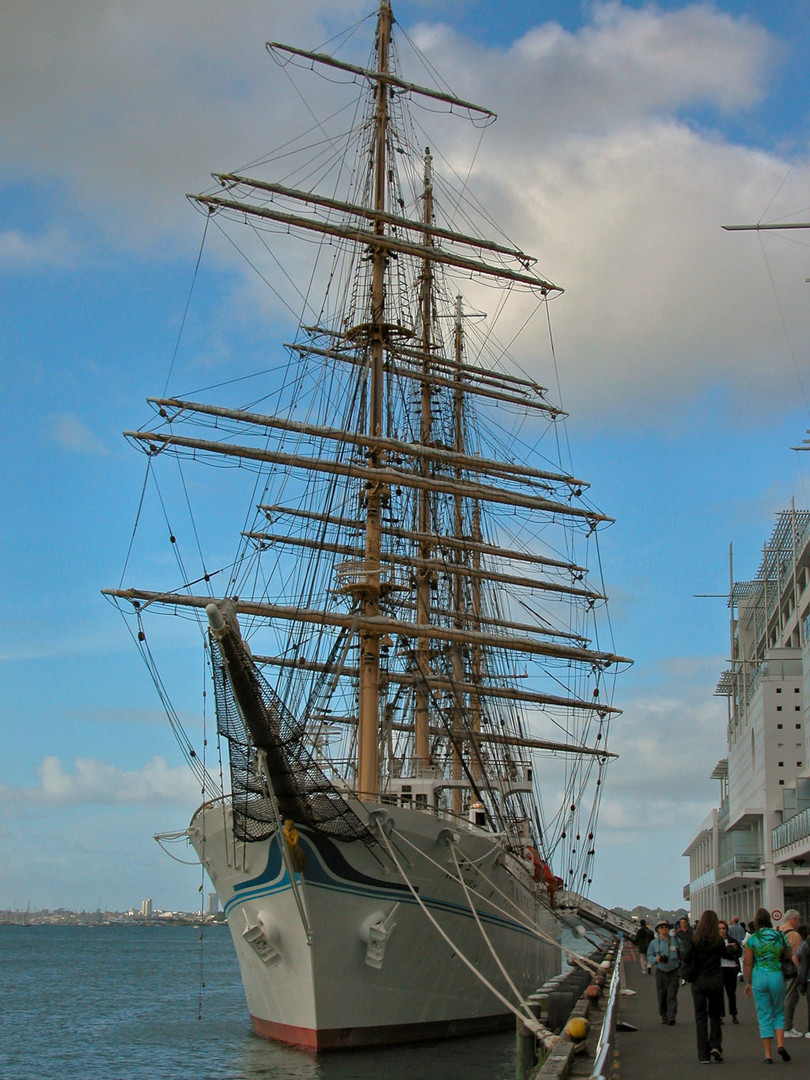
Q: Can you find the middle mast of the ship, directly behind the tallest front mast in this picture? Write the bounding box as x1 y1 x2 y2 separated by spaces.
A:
414 150 433 774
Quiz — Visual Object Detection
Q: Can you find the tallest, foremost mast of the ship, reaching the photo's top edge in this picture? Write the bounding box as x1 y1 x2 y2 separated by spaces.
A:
357 0 392 799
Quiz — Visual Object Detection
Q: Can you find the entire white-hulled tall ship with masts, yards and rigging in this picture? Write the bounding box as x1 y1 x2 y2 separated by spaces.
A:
107 0 623 1050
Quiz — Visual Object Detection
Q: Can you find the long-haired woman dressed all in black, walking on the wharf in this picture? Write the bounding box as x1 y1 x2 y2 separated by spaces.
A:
683 909 726 1065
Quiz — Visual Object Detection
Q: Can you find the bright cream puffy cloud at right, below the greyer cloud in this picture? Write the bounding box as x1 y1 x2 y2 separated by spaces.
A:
494 122 810 419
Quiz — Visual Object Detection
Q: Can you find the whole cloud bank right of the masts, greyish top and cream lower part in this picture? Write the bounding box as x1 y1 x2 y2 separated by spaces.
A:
393 3 810 423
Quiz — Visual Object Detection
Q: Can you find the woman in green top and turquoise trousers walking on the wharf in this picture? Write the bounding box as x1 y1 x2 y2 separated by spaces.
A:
743 907 791 1064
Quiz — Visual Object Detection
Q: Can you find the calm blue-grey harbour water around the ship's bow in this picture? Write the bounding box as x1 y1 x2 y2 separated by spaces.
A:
0 926 515 1080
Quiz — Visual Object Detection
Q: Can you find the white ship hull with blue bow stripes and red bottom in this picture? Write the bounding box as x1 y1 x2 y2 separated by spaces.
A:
189 804 559 1050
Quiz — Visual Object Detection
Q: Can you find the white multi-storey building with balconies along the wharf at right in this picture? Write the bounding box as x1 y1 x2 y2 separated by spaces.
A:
684 510 810 922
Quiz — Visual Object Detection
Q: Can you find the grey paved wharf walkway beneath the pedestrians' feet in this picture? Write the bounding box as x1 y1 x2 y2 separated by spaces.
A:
596 949 810 1080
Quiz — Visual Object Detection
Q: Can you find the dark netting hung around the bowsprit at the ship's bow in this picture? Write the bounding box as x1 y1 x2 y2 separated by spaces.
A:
211 634 375 845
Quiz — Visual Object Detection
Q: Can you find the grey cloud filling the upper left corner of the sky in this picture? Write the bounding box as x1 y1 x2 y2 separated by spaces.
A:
0 0 359 249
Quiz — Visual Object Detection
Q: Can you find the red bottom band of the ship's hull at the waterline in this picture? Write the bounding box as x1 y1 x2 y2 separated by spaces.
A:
251 1013 514 1051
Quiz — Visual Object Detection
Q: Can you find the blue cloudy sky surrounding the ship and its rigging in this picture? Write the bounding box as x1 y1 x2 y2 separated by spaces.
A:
0 0 810 909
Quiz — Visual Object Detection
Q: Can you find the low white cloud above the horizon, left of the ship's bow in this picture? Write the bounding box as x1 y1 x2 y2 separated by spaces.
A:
0 755 200 807
